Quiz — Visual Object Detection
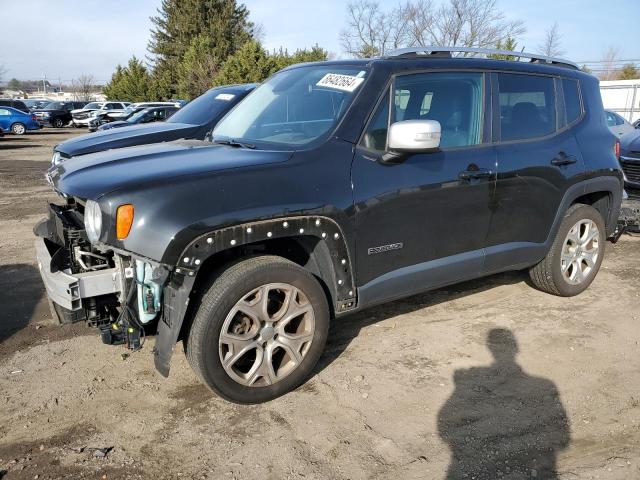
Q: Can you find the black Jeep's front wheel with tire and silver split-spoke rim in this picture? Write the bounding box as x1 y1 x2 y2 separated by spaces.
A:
186 256 329 404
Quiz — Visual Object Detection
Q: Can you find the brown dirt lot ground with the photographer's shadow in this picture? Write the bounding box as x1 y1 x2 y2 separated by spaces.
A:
0 130 640 479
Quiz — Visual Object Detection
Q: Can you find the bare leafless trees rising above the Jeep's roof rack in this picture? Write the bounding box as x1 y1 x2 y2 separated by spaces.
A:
340 0 525 57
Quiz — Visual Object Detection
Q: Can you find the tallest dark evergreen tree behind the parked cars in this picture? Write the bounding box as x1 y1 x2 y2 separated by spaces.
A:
148 0 253 98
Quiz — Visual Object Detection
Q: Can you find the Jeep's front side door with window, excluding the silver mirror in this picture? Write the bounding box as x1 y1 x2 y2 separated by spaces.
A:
352 72 496 303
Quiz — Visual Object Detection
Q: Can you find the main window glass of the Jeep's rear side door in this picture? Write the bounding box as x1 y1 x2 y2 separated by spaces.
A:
498 73 556 141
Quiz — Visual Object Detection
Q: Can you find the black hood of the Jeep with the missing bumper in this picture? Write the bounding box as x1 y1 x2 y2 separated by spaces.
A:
47 140 293 200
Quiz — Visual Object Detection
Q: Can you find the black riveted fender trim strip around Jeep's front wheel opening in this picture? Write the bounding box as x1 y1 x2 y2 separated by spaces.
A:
154 215 356 377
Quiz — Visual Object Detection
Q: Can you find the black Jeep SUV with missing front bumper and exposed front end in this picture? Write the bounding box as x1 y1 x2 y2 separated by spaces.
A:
35 47 623 403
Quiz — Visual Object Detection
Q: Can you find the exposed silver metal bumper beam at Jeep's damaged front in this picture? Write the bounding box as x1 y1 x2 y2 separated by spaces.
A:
35 237 123 311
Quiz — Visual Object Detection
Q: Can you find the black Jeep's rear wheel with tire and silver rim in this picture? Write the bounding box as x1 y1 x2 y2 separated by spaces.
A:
529 204 606 297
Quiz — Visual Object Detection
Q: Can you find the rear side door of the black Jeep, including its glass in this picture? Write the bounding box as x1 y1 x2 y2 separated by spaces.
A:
485 73 584 272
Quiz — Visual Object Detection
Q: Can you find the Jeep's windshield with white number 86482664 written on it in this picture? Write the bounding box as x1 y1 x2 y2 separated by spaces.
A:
213 65 368 147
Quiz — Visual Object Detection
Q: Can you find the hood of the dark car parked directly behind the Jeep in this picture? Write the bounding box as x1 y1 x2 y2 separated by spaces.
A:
54 122 199 157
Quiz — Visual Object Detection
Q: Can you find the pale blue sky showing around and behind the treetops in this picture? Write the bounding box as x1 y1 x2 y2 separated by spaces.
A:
0 0 640 83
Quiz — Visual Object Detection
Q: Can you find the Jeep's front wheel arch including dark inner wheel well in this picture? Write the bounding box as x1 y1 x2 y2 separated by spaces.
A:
154 215 356 376
